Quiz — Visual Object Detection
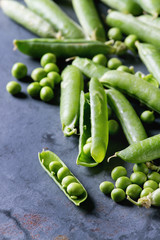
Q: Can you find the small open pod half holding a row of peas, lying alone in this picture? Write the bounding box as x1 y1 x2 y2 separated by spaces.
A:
38 150 87 206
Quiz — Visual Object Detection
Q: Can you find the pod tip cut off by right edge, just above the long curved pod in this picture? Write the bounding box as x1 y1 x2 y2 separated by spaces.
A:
136 41 160 83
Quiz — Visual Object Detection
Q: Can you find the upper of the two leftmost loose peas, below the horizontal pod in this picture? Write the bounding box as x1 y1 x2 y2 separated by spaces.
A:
11 63 27 79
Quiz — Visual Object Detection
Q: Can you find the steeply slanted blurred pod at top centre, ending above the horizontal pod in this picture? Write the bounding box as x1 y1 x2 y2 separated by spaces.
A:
72 0 106 42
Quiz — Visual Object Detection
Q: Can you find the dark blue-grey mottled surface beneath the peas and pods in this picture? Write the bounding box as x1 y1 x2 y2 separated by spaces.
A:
0 1 160 240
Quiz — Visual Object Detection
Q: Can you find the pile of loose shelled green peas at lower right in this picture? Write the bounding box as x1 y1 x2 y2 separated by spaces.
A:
99 163 160 202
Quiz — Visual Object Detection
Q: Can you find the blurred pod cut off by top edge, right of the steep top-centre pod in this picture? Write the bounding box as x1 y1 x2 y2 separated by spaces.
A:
101 0 142 15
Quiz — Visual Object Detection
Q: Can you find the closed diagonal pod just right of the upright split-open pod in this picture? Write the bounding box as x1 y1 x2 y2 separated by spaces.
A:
106 89 147 144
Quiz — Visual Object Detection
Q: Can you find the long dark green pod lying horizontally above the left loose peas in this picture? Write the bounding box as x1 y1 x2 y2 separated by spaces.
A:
14 38 116 58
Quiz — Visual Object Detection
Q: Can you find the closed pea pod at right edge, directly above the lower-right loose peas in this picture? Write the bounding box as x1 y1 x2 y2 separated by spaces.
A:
115 134 160 163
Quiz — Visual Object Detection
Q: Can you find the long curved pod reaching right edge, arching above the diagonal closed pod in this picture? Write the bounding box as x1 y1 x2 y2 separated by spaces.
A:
100 70 160 113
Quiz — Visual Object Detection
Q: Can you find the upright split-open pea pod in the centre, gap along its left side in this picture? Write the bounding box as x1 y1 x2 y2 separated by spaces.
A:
77 78 108 167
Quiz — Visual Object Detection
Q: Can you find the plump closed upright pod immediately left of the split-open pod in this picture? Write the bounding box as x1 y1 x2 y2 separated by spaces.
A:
60 65 83 136
